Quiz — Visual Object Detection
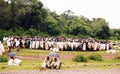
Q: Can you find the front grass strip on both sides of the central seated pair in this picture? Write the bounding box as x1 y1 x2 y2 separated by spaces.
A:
0 60 120 71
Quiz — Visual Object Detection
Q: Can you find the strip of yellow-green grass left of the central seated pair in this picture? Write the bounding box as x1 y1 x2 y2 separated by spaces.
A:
0 60 42 71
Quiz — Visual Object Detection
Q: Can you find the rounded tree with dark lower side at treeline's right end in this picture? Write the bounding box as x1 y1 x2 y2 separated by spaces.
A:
91 18 110 39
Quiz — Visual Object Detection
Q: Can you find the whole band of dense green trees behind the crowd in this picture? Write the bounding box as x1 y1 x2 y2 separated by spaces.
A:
0 0 120 40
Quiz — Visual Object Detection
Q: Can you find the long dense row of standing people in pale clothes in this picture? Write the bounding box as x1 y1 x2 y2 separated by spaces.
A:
3 36 112 51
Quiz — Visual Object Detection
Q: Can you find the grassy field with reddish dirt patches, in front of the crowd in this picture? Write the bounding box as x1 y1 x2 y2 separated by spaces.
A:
0 49 120 71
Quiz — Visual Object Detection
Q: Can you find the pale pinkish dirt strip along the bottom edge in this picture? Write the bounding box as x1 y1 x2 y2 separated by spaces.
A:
0 69 120 74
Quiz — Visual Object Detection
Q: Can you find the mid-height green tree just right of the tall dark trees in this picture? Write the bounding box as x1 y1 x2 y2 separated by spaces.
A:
42 12 60 36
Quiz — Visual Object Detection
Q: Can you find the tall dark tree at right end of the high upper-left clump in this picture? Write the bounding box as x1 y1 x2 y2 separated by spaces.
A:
18 0 47 30
